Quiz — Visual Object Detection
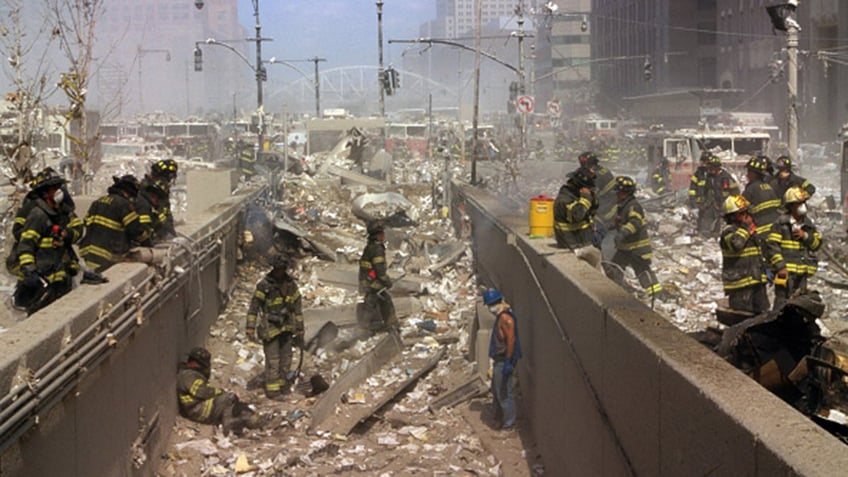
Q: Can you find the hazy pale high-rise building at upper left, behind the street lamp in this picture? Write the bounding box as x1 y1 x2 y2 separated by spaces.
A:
93 0 248 118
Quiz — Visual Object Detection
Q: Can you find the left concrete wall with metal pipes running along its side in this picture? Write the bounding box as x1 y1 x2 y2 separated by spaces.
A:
0 184 257 477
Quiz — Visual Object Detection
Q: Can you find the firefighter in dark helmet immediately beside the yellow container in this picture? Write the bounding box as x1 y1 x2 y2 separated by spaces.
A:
554 167 601 267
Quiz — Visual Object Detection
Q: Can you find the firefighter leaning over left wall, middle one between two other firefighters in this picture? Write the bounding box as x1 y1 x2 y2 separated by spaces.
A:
80 175 153 272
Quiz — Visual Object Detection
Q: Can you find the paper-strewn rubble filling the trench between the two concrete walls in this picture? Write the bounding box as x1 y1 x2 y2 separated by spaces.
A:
158 147 530 476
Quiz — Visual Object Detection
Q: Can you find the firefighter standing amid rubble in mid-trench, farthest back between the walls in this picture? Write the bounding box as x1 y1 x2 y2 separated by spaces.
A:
359 220 399 332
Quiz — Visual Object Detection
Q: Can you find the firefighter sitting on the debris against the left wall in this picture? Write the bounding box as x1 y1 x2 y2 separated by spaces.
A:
177 346 262 435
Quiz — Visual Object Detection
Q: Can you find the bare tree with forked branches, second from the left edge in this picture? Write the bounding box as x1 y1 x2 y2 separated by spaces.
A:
44 0 105 193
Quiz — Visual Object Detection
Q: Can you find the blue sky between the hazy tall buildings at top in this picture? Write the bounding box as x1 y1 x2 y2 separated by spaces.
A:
239 0 436 80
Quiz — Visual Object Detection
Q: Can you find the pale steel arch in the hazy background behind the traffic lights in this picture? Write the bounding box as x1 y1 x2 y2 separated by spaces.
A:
268 65 460 113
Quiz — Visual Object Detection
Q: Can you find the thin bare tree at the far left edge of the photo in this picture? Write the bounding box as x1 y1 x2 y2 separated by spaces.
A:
0 0 55 185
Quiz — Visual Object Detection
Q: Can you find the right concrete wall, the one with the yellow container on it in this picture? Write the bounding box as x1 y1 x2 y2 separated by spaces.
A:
454 186 848 476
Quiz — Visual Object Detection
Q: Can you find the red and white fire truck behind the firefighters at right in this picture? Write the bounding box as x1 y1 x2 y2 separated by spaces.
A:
662 129 771 189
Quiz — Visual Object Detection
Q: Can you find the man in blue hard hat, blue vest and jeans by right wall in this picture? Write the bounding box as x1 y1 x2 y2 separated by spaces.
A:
483 288 521 430
